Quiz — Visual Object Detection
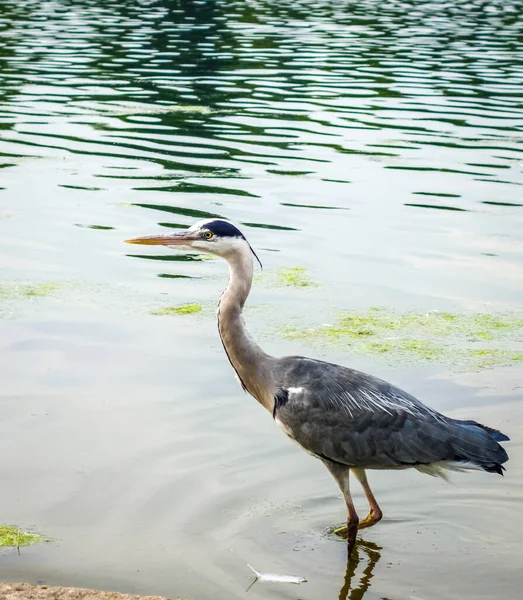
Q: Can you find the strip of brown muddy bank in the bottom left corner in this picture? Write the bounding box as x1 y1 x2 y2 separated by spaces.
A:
0 583 182 600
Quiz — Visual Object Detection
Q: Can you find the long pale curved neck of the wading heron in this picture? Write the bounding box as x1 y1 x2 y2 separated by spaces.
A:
218 250 274 410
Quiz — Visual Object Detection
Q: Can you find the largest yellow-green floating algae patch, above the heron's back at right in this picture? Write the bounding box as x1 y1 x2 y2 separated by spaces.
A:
283 307 523 370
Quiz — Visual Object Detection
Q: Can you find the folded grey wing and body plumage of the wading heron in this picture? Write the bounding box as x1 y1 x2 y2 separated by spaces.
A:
274 357 504 469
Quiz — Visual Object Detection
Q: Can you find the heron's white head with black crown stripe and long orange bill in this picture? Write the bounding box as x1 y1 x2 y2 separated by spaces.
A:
125 219 261 266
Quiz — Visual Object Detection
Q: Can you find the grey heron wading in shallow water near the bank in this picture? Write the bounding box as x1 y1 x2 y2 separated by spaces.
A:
126 219 509 556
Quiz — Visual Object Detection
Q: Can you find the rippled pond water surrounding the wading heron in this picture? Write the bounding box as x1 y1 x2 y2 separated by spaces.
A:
0 0 523 600
